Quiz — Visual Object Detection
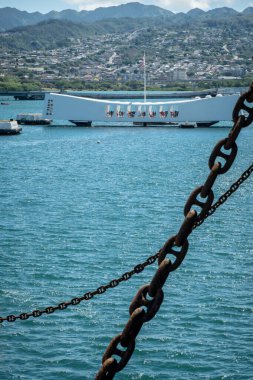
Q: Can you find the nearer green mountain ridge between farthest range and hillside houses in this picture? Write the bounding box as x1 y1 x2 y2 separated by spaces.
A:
0 12 253 51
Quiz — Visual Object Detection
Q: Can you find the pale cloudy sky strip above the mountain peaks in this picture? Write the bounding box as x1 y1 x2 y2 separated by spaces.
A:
0 0 253 13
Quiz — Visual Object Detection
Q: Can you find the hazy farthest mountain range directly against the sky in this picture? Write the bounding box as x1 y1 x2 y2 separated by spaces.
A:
0 2 253 32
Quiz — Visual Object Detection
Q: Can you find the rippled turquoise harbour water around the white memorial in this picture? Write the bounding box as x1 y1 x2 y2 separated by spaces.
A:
0 101 253 380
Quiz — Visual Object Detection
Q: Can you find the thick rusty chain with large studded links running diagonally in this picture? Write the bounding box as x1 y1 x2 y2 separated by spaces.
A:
96 83 253 380
